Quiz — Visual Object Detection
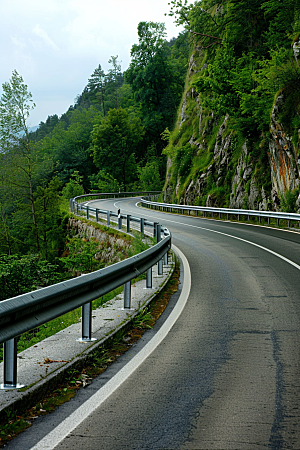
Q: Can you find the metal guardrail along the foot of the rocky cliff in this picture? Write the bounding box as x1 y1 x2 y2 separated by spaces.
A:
141 198 300 227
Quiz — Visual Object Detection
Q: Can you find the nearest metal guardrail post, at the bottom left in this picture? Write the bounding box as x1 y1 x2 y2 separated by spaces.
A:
0 338 24 389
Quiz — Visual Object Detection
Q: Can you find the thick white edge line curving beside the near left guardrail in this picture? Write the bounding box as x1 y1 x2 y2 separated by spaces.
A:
31 245 191 450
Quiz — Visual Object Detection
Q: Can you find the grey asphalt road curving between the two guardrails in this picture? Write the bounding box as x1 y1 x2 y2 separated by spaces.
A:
8 199 300 450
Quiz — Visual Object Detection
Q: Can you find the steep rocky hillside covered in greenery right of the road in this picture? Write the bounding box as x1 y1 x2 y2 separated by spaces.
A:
164 0 300 211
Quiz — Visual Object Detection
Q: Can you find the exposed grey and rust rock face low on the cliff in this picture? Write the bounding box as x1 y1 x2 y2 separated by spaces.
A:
164 49 300 210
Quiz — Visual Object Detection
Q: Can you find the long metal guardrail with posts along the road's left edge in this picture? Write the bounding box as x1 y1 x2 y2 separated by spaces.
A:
0 194 171 389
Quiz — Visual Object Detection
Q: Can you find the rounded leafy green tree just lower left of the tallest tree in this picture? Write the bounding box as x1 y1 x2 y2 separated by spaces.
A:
92 108 144 190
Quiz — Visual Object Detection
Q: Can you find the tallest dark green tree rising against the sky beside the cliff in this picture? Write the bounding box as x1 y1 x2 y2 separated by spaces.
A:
125 22 184 149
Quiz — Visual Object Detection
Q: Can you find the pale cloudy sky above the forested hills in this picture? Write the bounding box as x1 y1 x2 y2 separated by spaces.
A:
0 0 192 126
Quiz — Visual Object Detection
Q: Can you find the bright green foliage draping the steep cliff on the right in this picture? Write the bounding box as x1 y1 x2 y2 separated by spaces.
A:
165 0 300 206
